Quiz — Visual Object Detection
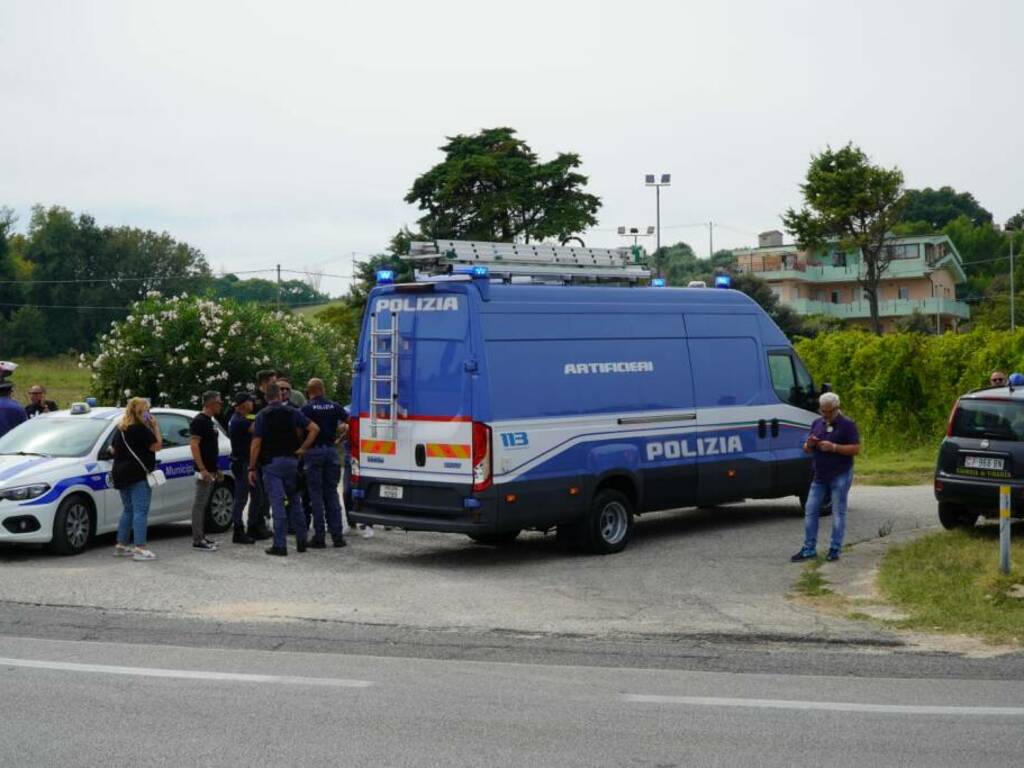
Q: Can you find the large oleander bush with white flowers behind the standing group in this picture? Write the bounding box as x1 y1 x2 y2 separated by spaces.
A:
86 292 352 408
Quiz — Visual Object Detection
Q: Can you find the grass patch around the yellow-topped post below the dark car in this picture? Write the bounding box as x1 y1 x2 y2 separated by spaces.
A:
879 523 1024 645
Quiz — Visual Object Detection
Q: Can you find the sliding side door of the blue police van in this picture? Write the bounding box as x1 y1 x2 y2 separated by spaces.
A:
686 314 777 504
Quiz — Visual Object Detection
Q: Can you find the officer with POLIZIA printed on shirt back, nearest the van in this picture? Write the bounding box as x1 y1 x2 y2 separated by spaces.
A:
301 379 348 549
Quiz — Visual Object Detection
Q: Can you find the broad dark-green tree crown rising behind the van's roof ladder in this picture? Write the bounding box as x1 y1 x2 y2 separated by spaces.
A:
406 128 601 243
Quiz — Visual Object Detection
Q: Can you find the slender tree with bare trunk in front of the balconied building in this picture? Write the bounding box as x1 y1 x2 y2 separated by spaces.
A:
782 143 903 335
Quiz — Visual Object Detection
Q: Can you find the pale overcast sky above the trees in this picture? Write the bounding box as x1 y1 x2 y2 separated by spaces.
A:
0 0 1024 293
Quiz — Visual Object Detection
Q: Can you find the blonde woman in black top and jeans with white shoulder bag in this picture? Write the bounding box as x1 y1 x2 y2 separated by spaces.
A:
111 397 164 560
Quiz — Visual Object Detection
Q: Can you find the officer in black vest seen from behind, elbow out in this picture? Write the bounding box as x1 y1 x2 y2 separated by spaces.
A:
249 383 319 557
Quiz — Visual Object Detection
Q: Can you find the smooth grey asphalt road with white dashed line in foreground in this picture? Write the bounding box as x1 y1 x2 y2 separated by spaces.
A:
0 638 1024 768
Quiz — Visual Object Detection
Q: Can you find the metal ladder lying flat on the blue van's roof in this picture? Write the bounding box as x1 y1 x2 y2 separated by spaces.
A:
402 240 650 283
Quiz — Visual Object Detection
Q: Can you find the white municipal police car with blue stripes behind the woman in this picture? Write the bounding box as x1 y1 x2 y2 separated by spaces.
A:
0 403 234 555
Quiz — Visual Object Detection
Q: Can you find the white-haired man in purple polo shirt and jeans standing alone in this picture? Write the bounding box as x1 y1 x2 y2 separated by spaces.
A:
790 392 860 562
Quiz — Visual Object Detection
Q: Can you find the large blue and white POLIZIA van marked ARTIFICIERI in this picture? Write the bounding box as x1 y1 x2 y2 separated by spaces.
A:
349 252 817 553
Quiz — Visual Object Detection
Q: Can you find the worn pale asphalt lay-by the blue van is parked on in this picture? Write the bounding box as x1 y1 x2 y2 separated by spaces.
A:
0 486 936 644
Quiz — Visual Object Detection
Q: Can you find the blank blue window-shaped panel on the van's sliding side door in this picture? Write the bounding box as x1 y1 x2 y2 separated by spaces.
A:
689 339 761 408
